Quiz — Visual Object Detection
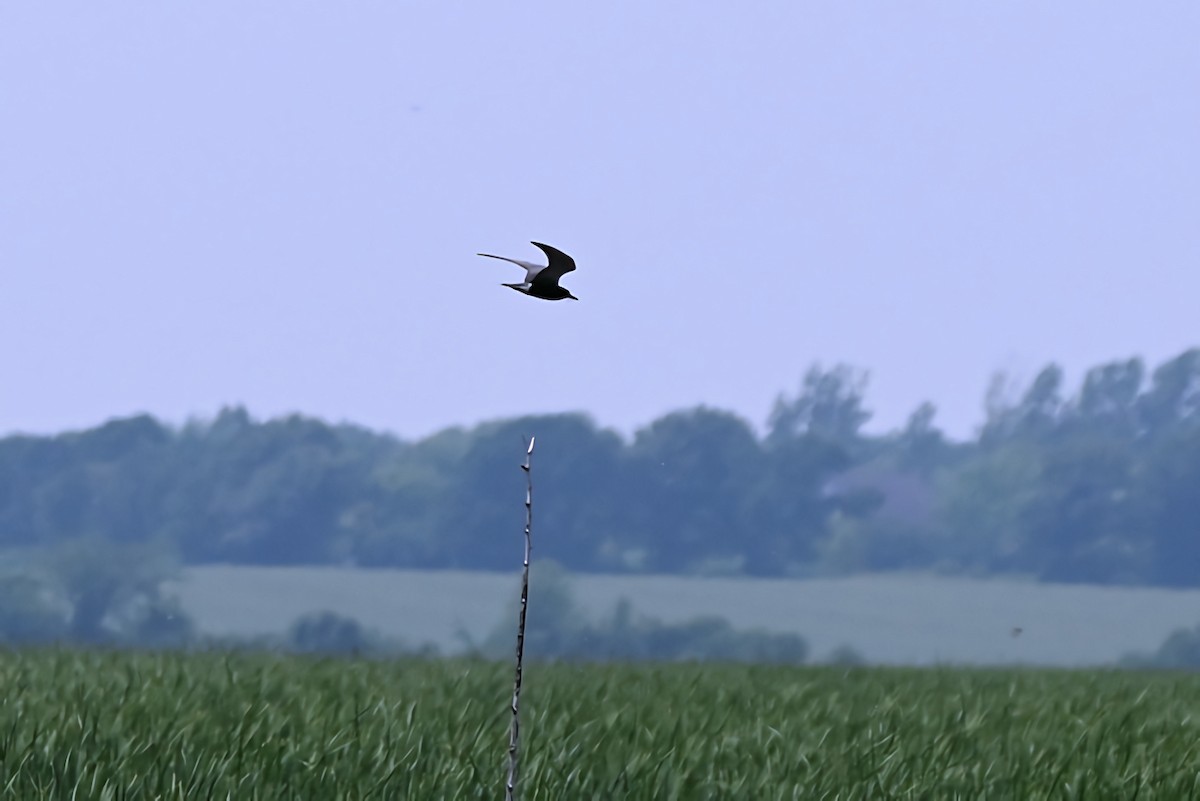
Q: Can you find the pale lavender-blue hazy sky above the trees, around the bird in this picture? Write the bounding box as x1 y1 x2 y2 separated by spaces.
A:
0 0 1200 436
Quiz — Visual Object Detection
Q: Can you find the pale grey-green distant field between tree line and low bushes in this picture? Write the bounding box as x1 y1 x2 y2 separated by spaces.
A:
166 566 1200 666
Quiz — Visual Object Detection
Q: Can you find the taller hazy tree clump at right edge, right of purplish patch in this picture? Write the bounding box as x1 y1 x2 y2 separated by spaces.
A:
940 349 1200 586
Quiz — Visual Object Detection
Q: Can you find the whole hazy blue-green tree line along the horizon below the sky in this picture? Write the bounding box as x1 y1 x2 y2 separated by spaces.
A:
0 349 1200 586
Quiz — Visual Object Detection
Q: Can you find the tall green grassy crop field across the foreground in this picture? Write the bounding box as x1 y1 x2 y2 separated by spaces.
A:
0 651 1200 801
